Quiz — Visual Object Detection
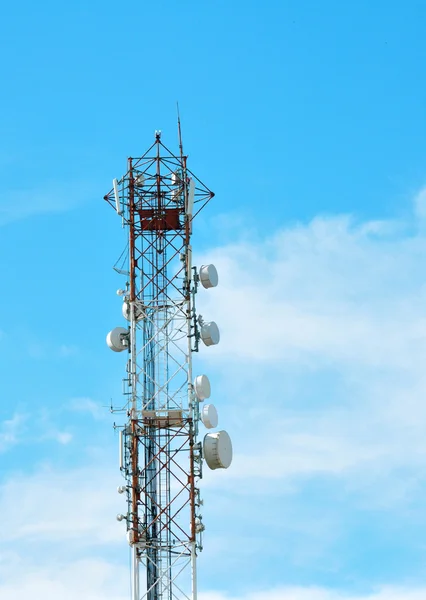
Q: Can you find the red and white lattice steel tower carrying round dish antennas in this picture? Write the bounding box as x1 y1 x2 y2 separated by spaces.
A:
104 130 232 600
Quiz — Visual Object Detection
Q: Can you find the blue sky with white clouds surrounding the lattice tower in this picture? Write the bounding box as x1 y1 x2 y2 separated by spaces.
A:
0 0 426 600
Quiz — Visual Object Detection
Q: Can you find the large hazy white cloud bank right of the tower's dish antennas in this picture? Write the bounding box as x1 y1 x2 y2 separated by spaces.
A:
198 191 426 502
